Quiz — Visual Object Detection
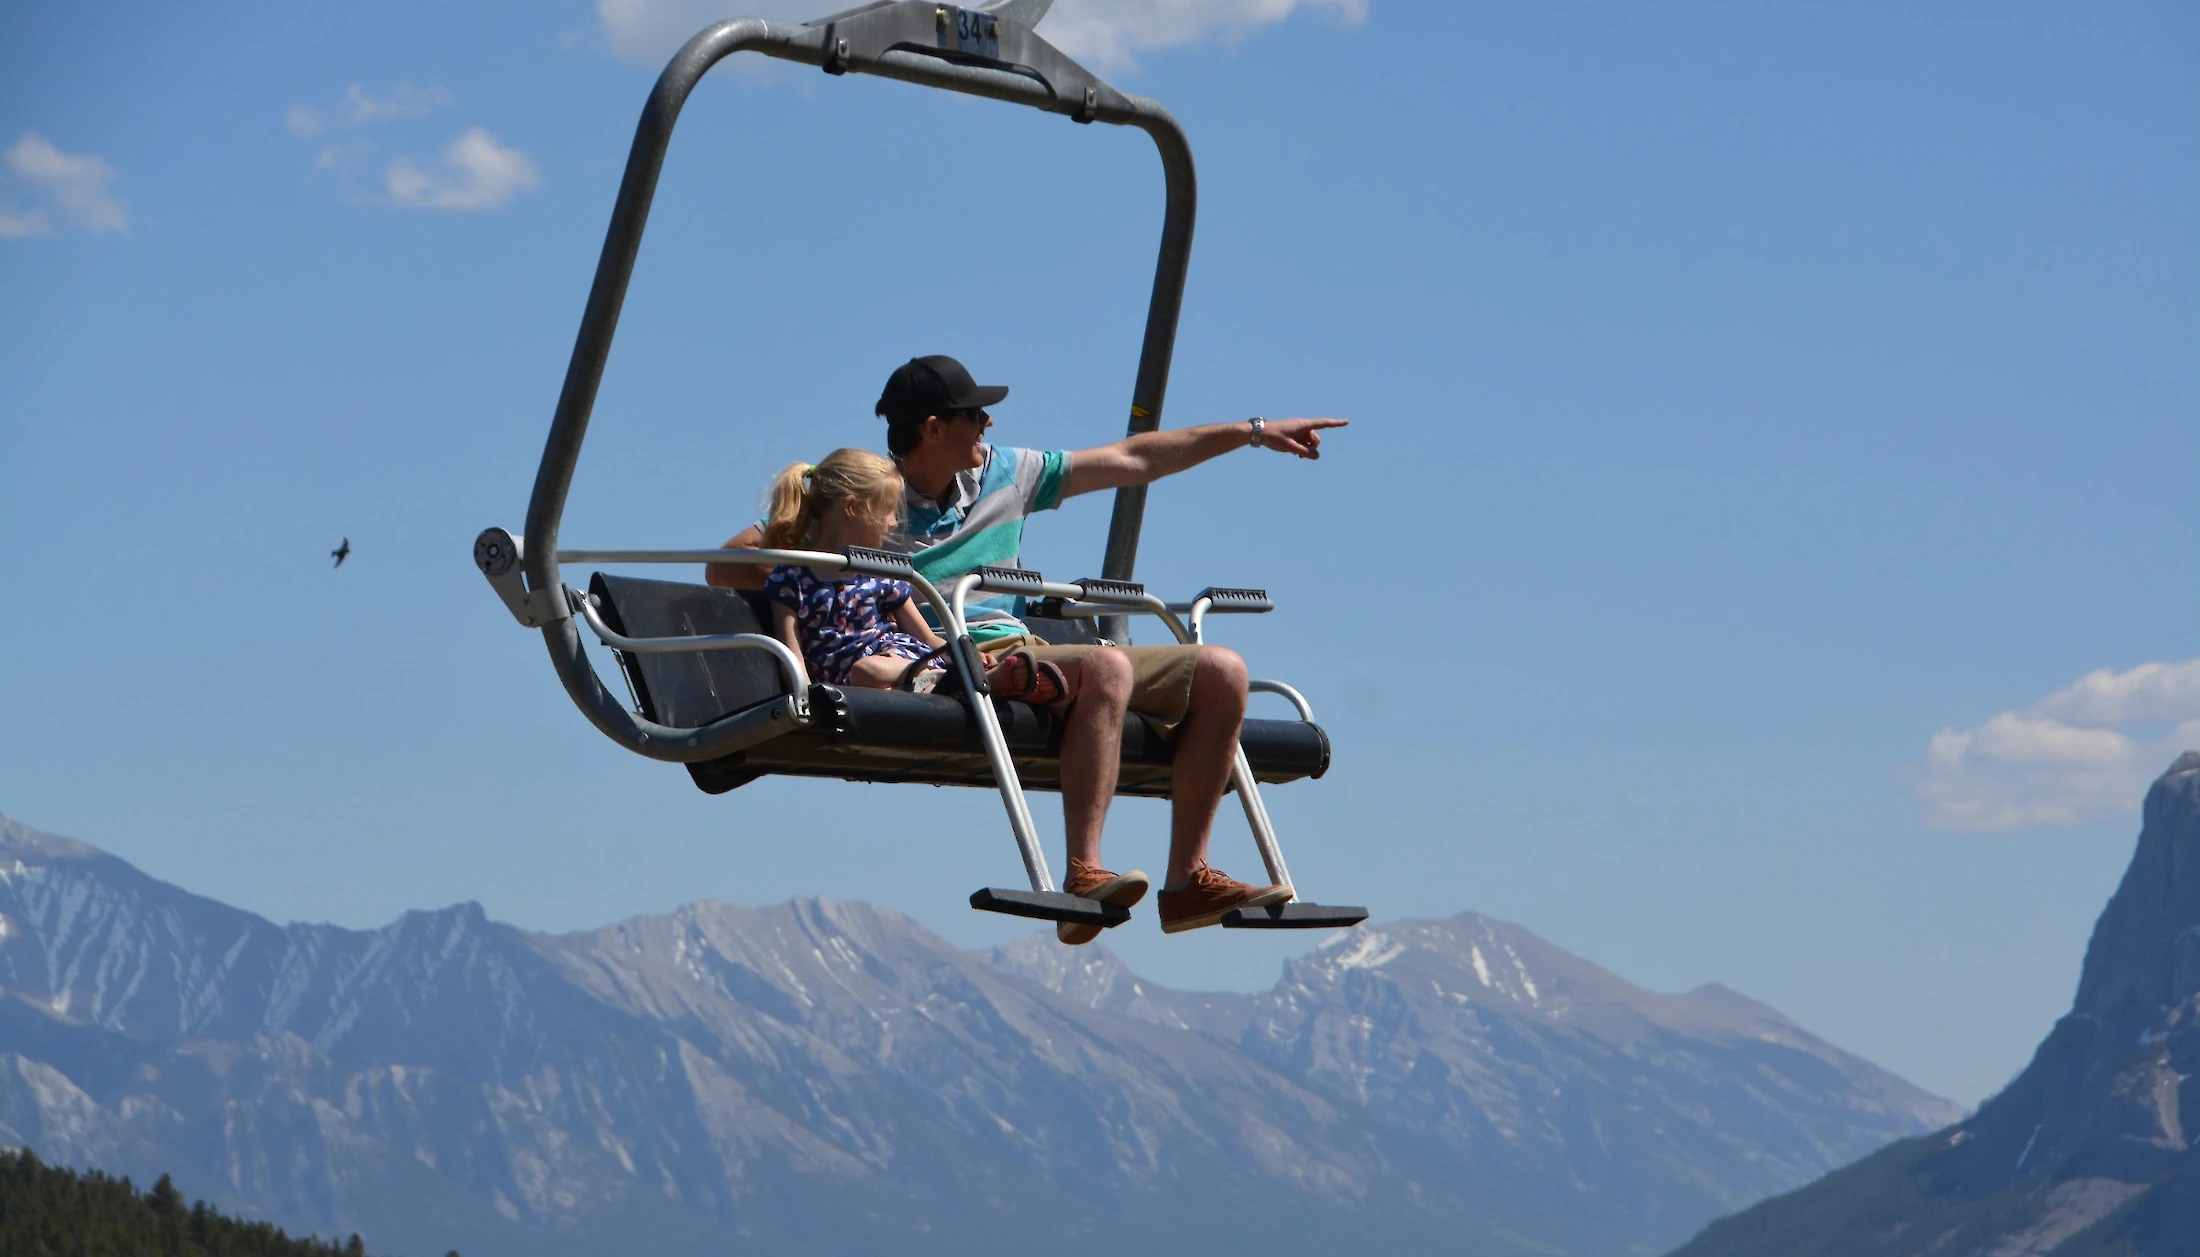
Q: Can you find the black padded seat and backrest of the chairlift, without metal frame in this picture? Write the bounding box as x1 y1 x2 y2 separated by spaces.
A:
590 572 1329 797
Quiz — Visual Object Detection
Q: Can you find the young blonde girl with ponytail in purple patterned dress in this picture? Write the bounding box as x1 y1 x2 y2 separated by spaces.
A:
763 449 1069 702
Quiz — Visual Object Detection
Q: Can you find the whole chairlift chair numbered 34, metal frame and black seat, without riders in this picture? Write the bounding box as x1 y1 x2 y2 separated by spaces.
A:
473 0 1366 929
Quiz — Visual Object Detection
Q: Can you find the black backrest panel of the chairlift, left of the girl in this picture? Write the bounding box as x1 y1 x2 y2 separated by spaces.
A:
587 572 785 729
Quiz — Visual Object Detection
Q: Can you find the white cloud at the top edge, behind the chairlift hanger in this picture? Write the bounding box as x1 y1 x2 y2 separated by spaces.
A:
596 0 1368 70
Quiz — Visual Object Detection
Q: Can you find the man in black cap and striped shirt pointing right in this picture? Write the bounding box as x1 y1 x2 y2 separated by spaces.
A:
706 354 1346 944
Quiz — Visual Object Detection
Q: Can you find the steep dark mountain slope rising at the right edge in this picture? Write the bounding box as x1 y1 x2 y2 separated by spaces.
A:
1674 751 2200 1257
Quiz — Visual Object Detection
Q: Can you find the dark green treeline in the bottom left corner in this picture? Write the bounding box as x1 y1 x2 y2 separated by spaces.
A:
0 1149 458 1257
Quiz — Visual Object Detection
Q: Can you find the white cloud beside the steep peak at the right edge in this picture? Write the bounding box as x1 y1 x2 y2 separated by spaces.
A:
1918 658 2200 830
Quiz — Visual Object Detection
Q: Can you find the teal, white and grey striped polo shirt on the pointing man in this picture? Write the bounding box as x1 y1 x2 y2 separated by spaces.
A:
887 445 1069 641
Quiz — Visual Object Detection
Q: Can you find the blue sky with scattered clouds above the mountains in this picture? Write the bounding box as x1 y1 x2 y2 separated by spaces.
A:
0 0 2200 1103
